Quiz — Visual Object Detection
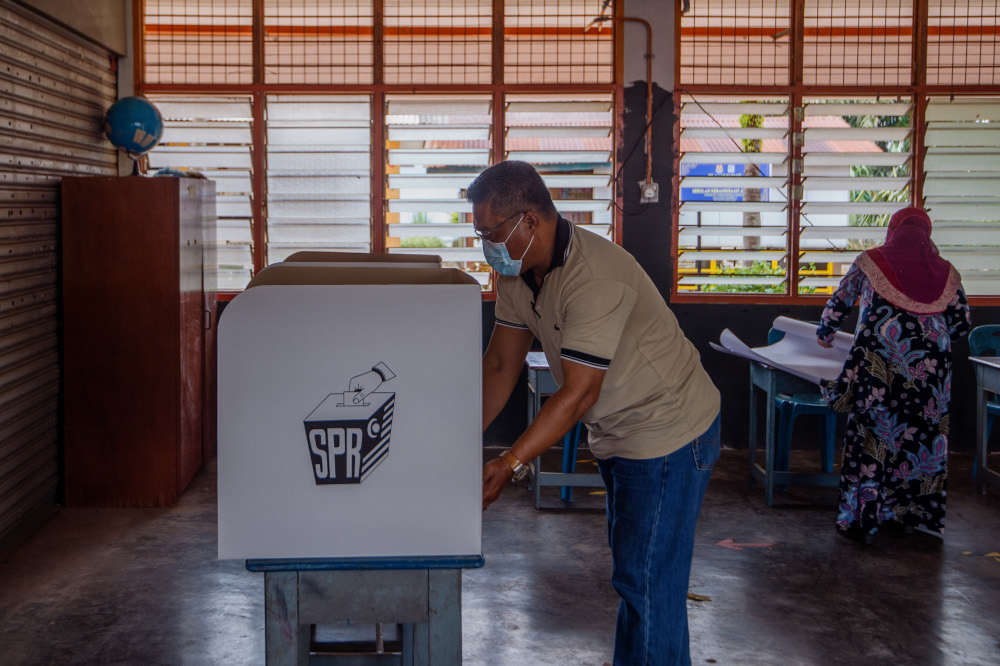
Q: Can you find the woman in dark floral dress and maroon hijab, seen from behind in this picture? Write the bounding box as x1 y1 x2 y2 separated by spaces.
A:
816 208 971 543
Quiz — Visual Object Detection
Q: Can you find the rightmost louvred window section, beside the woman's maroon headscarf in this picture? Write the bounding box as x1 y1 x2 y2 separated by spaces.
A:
924 96 1000 296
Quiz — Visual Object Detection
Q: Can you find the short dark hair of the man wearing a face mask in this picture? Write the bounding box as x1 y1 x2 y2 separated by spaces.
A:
466 160 556 217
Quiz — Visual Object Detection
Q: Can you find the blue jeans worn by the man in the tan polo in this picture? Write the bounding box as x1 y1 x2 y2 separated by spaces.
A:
597 416 719 666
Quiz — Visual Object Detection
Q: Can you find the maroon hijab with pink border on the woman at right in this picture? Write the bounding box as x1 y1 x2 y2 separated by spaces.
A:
857 208 961 314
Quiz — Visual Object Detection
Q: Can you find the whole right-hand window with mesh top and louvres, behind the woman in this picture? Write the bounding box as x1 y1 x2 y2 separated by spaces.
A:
675 0 1000 297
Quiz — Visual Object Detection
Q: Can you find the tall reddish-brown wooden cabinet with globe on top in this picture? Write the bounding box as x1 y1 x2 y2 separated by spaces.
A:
62 177 215 506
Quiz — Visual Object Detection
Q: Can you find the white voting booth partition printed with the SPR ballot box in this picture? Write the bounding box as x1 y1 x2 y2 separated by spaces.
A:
218 264 482 559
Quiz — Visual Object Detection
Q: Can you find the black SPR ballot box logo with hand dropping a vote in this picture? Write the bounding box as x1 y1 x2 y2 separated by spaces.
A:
305 363 396 485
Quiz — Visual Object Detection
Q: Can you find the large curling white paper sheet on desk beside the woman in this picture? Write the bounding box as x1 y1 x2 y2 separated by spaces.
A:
709 317 854 384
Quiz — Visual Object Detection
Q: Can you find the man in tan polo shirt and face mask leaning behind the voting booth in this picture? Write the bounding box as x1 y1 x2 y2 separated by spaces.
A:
468 161 719 666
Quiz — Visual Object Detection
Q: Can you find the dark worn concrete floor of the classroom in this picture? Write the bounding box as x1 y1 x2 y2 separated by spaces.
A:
0 451 1000 666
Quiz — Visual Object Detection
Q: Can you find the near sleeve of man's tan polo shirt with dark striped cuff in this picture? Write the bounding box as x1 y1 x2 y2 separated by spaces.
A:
559 280 636 369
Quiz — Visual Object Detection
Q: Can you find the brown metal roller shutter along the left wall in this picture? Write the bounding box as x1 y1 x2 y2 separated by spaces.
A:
0 0 118 546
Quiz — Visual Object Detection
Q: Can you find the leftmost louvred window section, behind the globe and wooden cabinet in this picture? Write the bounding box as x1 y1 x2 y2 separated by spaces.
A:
149 95 253 291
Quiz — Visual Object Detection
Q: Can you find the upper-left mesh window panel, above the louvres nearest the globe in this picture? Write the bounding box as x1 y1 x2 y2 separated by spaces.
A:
141 0 253 84
